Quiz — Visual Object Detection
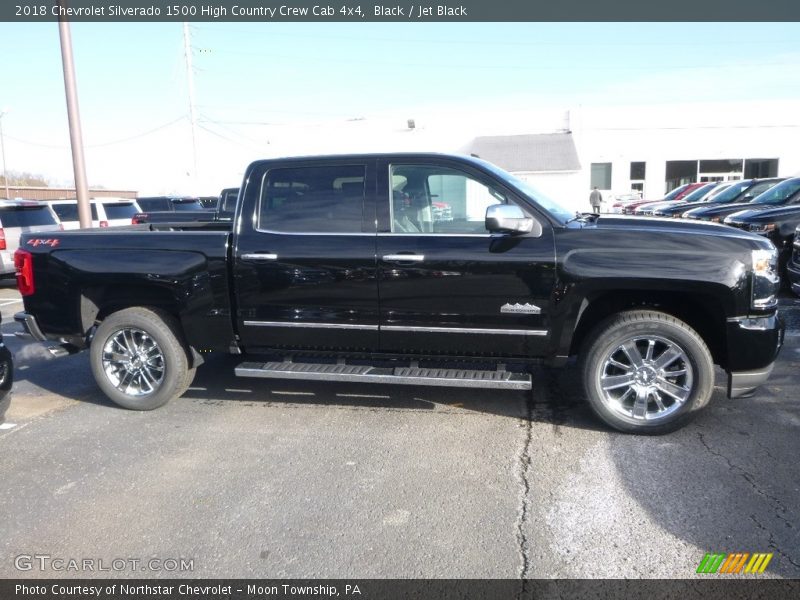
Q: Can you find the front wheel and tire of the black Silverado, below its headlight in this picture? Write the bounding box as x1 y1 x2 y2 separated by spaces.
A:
581 310 714 434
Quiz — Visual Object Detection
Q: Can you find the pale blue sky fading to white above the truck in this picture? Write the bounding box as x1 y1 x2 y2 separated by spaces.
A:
0 23 800 195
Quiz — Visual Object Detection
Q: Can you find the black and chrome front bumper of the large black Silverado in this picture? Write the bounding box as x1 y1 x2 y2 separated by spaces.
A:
727 312 784 398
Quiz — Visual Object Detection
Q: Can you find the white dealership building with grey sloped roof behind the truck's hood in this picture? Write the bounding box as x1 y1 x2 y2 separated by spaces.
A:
466 102 800 210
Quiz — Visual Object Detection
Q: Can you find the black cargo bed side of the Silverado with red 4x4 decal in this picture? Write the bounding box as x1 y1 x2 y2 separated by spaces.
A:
20 227 234 350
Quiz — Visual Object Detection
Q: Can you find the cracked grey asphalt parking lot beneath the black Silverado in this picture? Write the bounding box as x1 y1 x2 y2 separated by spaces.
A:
0 286 800 578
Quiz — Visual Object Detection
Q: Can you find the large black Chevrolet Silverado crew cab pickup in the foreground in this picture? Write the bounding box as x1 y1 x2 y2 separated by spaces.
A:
15 154 783 433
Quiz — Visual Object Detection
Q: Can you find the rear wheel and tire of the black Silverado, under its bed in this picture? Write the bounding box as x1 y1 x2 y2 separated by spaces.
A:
89 307 195 410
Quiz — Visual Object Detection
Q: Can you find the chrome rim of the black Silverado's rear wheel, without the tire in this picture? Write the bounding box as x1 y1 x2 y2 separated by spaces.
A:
102 328 165 397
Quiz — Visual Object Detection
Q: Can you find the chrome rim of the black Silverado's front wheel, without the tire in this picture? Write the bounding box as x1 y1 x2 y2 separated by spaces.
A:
598 335 694 421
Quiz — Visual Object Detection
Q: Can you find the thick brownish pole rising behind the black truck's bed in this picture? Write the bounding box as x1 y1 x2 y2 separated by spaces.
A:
58 0 92 229
